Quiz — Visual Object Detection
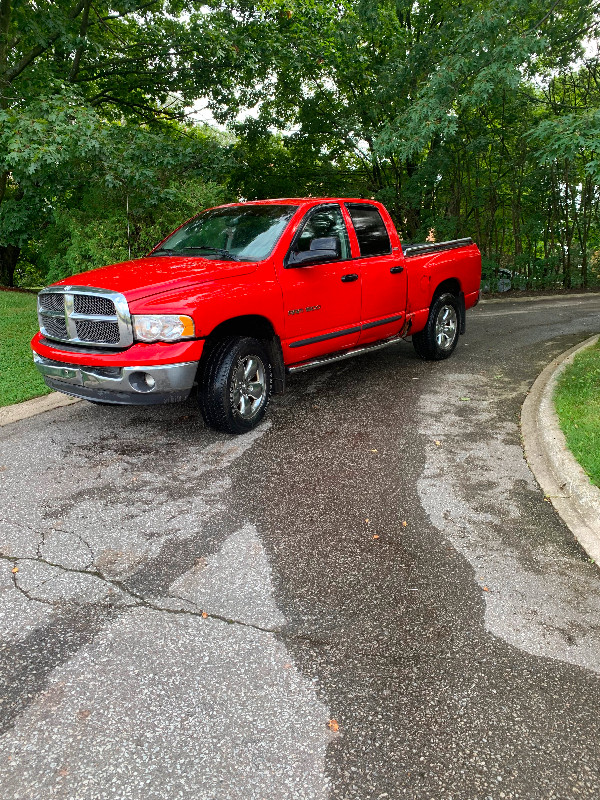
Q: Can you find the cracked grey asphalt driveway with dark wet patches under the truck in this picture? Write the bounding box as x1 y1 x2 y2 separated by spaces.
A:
0 296 600 800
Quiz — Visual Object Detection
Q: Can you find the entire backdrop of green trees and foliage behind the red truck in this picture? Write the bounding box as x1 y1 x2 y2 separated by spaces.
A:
0 0 600 288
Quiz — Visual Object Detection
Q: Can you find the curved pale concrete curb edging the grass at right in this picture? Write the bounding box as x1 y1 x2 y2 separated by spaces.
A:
521 336 600 564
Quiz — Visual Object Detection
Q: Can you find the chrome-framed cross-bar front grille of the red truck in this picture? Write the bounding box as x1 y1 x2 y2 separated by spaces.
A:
38 286 133 348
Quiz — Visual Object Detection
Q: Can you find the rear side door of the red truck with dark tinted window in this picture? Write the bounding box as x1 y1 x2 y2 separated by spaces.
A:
345 203 407 343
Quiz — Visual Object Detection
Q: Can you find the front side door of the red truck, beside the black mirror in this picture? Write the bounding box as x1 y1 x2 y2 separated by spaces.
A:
278 203 361 364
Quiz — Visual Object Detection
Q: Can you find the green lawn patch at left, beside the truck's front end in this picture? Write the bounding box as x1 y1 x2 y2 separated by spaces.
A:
0 291 50 406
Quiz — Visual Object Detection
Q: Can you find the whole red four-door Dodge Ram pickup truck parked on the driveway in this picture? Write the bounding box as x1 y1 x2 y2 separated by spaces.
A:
31 198 481 433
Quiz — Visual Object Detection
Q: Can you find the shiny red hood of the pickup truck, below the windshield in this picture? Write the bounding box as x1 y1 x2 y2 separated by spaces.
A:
54 256 258 301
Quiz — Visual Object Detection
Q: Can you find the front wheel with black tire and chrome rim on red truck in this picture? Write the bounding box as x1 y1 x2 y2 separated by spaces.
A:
198 336 273 433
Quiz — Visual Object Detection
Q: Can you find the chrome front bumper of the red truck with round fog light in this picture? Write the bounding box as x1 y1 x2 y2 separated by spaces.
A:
33 353 198 405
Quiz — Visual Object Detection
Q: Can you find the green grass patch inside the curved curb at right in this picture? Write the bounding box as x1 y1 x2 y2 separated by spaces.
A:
554 343 600 486
